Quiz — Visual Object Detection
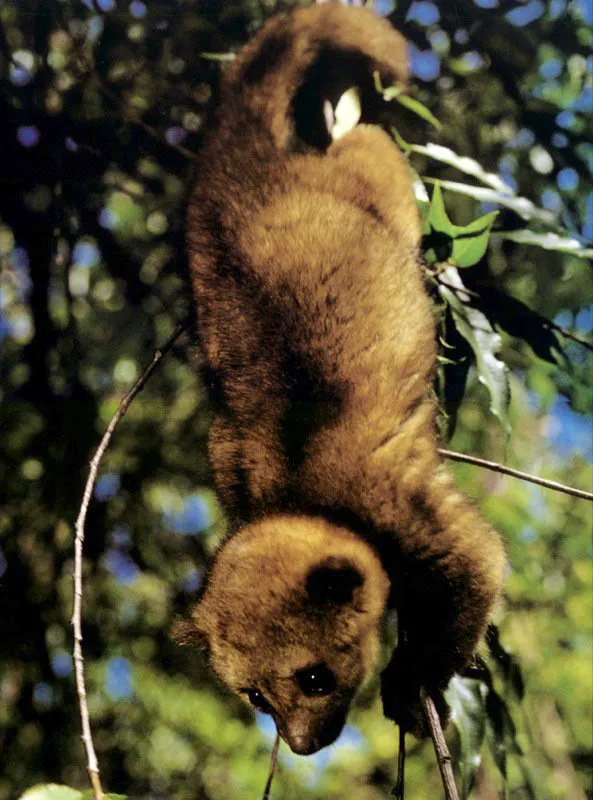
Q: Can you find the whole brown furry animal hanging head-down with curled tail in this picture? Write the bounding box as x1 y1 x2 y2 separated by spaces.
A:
177 4 504 754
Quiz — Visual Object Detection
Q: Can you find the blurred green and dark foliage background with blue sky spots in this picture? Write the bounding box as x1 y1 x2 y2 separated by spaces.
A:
0 0 593 800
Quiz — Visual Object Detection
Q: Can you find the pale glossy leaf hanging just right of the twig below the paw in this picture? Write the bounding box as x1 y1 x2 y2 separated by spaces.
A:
445 675 487 800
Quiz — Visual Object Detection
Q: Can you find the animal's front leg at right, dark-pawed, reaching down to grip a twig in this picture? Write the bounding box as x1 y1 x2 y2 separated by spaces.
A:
382 472 505 733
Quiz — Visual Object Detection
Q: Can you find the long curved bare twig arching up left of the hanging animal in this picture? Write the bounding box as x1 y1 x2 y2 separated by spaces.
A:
72 321 187 800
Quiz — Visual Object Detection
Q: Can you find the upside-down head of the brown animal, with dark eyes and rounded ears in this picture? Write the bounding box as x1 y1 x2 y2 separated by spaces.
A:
174 516 389 755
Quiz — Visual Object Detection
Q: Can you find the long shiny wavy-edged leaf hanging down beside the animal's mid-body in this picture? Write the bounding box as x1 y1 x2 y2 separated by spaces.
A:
439 267 511 433
